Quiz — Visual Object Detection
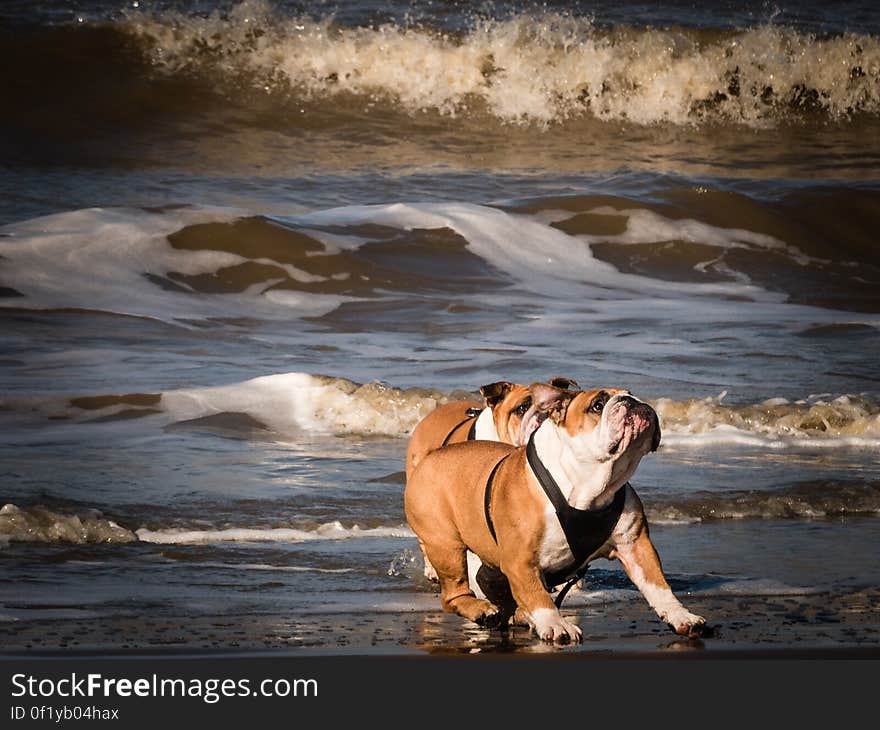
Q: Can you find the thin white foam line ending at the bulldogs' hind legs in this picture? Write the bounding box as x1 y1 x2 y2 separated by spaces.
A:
136 521 414 545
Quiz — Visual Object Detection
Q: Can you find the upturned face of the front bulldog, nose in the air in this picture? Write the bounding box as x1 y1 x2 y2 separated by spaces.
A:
529 383 660 490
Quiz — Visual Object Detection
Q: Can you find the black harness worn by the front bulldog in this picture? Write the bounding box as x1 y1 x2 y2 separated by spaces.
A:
483 434 628 607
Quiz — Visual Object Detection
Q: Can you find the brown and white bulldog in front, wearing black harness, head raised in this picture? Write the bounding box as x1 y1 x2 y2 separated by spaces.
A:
405 383 705 641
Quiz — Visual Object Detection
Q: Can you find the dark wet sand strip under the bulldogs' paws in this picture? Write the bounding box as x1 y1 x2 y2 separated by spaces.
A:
0 588 880 658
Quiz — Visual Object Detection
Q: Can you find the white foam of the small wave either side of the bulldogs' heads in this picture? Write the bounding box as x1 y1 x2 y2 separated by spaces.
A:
161 373 880 440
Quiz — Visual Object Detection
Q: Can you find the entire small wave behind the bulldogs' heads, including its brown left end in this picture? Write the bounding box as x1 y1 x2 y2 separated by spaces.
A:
2 372 880 450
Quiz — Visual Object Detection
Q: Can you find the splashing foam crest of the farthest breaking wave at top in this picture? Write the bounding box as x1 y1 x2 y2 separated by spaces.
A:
127 0 880 126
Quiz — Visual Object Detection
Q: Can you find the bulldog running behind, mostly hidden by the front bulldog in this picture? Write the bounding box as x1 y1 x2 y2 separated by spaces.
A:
406 376 578 581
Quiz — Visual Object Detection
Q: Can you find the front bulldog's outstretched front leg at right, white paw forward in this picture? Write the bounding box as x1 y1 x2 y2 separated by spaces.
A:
613 525 706 636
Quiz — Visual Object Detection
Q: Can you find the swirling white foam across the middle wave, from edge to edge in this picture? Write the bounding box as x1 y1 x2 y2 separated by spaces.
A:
0 199 877 338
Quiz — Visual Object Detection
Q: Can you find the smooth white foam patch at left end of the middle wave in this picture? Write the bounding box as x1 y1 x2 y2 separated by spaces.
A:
0 207 354 322
